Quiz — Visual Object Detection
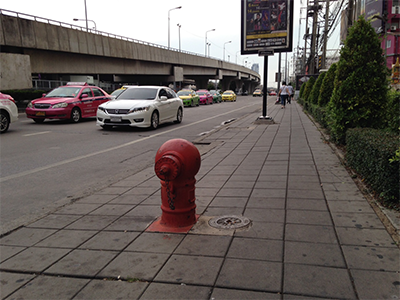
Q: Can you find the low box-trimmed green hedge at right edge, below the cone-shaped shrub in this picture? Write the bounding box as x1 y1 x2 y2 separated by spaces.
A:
346 128 400 208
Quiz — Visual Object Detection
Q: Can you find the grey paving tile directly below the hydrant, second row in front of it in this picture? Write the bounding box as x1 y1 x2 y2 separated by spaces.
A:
155 254 223 285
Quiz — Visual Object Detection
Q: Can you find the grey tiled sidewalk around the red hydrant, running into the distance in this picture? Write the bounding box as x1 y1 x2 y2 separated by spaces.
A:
0 102 400 300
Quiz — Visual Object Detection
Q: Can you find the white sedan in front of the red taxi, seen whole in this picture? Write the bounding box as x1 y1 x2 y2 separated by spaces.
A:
96 86 183 129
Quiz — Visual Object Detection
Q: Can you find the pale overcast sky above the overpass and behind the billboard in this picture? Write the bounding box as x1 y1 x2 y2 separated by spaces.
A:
0 0 339 86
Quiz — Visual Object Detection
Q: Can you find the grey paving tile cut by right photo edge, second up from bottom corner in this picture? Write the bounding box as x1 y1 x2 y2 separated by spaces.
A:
342 246 400 272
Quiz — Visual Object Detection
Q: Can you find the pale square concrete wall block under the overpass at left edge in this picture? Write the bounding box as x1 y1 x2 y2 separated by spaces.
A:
0 53 32 91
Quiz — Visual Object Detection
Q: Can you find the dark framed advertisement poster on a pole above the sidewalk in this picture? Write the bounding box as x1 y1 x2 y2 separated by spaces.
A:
241 0 293 54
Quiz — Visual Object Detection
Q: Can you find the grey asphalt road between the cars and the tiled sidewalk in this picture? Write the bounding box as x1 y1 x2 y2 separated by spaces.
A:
0 96 262 235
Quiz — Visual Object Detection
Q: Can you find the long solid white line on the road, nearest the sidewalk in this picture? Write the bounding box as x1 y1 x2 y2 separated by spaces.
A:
0 103 259 183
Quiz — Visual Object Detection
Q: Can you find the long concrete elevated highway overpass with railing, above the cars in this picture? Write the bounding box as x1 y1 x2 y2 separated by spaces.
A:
0 9 260 92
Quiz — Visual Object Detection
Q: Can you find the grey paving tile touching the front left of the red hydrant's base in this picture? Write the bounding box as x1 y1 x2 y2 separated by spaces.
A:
125 232 184 253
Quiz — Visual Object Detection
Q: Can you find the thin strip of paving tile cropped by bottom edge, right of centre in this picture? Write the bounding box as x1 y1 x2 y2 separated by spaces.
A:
210 288 281 300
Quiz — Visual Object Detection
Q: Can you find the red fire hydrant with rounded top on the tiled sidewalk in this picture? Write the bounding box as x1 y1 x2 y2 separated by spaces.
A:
150 139 201 232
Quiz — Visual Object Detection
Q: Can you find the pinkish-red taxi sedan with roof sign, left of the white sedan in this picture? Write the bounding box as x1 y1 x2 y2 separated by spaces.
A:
25 82 111 123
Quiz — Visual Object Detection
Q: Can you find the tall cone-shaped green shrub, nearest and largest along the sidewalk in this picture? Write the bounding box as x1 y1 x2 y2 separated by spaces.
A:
327 16 388 143
